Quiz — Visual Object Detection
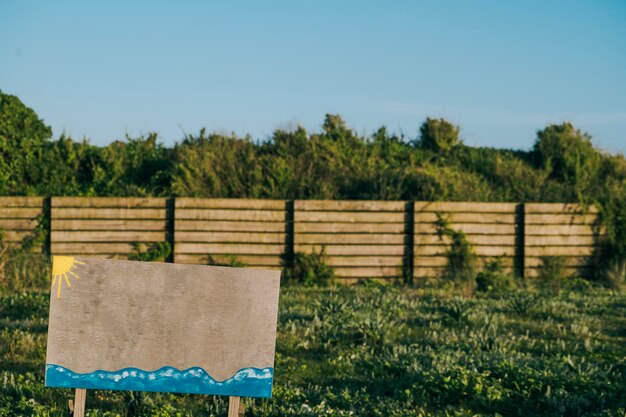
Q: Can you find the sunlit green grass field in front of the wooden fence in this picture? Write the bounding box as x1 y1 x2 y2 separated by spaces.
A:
0 286 626 416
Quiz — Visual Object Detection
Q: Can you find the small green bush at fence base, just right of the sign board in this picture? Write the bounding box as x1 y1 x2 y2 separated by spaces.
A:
285 247 335 286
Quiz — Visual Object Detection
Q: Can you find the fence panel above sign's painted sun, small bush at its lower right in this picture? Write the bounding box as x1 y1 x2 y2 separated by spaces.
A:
50 197 167 258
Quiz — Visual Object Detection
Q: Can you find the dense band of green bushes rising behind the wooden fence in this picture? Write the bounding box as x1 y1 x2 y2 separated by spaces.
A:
0 93 626 205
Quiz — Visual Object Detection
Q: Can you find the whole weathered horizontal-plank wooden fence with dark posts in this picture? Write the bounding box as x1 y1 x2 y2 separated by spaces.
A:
0 197 598 281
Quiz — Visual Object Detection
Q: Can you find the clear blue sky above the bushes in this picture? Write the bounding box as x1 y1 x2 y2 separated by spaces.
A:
0 0 626 152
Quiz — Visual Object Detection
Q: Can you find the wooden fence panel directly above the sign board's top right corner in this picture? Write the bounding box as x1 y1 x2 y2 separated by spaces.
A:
174 198 290 268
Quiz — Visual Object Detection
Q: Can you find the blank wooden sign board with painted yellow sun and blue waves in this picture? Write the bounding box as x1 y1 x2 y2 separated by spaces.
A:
46 256 280 397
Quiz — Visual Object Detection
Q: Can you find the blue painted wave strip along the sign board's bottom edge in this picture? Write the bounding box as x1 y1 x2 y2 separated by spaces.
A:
46 364 274 397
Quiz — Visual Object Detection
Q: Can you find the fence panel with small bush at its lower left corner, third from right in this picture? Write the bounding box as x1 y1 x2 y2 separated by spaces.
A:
294 200 407 282
